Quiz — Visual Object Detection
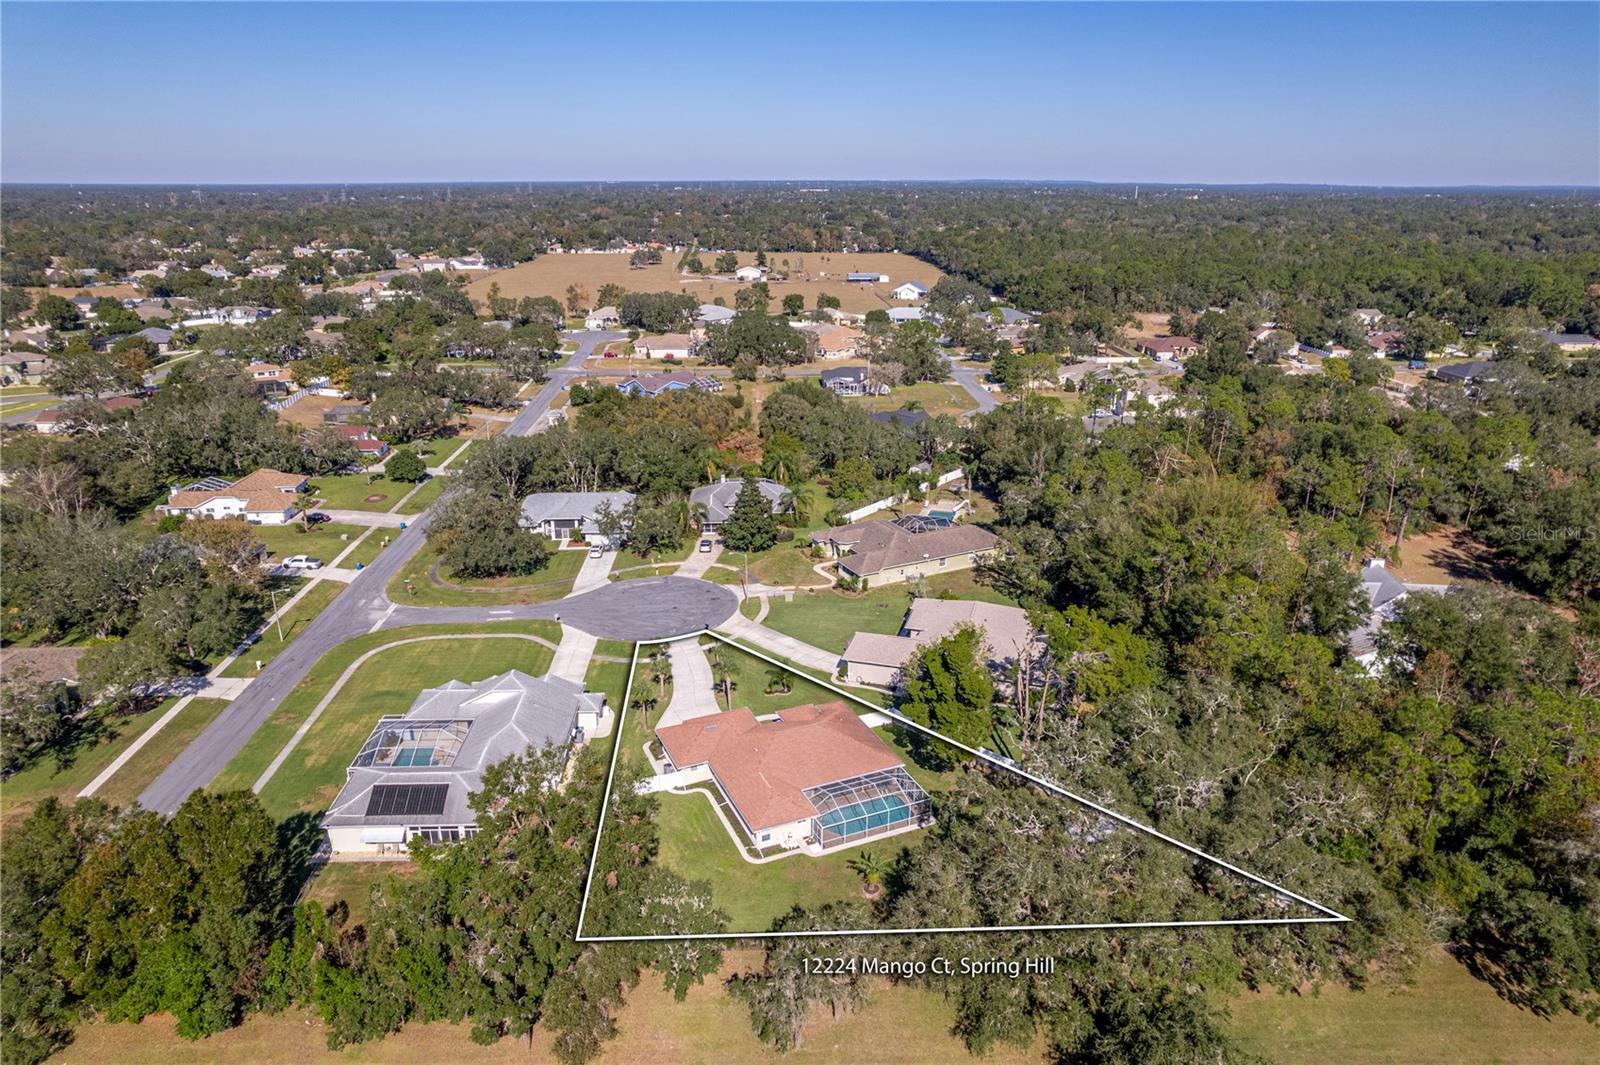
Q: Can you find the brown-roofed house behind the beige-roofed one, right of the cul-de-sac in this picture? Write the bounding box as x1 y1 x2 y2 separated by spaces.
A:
811 517 998 587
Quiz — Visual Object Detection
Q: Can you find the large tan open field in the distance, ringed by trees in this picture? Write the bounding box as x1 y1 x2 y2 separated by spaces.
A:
467 251 944 313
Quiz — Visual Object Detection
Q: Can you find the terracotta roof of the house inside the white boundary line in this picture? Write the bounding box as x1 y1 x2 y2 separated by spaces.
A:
656 702 904 832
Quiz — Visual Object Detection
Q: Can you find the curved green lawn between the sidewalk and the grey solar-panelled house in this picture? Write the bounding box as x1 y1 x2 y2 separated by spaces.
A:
261 638 555 817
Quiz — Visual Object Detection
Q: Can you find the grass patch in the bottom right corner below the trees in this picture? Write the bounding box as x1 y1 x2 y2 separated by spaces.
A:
1227 950 1600 1065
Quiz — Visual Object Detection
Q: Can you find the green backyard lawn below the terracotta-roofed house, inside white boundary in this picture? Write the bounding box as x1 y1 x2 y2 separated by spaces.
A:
656 783 923 932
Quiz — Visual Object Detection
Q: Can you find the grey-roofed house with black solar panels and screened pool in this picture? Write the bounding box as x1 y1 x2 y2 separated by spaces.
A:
322 670 606 859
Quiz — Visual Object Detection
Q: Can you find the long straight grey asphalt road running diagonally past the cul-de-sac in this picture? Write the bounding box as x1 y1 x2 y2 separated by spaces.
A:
139 333 626 814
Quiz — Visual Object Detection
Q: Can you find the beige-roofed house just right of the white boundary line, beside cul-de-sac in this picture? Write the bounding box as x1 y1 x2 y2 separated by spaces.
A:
845 598 1037 688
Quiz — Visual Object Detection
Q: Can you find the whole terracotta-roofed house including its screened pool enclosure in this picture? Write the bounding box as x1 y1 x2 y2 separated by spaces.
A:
656 702 931 854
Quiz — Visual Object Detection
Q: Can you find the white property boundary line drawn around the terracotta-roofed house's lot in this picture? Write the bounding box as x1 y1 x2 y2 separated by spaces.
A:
574 628 1352 943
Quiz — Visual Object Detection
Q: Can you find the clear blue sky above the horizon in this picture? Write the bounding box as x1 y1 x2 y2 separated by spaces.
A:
0 2 1600 185
